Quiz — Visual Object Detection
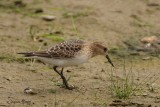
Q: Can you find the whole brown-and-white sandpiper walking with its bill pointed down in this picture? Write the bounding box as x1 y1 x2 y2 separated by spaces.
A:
17 39 114 90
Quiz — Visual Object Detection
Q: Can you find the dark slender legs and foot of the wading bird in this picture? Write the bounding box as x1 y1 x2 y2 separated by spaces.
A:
53 66 72 90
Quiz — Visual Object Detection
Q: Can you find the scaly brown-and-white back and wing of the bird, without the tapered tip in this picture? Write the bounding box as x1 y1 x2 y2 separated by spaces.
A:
47 40 85 58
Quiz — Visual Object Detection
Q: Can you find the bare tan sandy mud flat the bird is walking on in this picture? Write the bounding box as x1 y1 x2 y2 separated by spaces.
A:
0 0 160 107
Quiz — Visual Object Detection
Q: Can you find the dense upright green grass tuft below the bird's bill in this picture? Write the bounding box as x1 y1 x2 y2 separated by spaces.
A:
110 61 134 99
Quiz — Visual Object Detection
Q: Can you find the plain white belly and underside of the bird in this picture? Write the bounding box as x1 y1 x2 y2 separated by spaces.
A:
36 55 89 67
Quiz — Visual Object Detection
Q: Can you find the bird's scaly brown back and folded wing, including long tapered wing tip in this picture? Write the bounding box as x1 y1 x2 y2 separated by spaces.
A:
21 40 86 59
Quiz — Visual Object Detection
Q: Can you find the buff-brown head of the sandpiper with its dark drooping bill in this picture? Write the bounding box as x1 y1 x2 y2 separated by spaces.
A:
93 42 114 67
